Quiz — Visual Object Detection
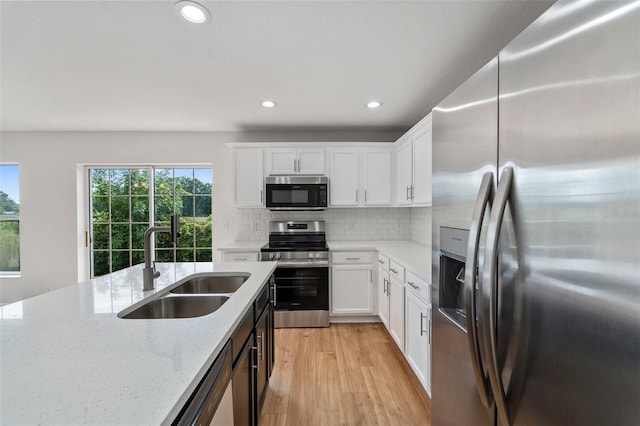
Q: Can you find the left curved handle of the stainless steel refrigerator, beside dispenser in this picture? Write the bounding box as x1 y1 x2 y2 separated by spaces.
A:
464 172 493 408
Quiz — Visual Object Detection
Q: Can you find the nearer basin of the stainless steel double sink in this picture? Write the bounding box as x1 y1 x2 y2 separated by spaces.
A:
118 295 229 319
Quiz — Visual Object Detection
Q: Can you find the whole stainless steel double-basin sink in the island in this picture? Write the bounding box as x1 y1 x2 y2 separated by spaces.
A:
118 272 250 319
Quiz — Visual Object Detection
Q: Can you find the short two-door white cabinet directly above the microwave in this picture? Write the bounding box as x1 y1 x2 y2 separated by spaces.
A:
267 148 326 175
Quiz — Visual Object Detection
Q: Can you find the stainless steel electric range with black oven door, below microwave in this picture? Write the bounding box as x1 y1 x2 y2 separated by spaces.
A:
261 220 329 328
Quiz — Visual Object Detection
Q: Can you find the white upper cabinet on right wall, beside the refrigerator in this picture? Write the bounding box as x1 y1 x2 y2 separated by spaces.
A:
395 114 432 206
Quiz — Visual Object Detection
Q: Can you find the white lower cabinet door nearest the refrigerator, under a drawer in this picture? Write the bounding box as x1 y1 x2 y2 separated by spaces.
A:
405 291 431 395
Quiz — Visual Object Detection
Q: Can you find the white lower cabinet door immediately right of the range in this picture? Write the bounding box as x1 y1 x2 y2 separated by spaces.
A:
331 265 373 315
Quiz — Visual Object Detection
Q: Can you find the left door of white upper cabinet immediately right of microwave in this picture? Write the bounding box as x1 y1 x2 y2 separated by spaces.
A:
329 149 359 206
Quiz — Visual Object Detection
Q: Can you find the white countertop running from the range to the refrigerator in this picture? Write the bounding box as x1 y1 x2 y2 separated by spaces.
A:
327 240 431 284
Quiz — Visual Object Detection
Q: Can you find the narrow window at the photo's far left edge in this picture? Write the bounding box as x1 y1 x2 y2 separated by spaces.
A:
0 164 20 275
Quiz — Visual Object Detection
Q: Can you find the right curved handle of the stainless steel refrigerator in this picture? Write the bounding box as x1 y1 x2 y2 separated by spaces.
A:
479 167 513 426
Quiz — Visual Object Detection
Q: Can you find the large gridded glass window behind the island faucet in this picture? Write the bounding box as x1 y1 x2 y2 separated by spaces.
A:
89 167 212 277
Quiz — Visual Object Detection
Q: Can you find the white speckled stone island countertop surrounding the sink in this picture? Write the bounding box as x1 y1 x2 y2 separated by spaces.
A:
0 262 276 425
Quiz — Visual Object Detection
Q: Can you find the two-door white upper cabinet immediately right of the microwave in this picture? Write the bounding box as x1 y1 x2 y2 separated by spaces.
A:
329 148 392 207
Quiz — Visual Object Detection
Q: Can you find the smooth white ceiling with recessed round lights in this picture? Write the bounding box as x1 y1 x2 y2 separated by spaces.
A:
0 0 551 131
